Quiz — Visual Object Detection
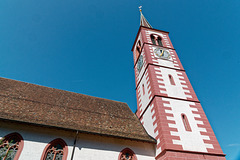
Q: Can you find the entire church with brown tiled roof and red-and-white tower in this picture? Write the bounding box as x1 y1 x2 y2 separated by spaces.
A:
0 9 225 160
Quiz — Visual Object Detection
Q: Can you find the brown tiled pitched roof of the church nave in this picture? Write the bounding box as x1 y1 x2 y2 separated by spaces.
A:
0 78 155 143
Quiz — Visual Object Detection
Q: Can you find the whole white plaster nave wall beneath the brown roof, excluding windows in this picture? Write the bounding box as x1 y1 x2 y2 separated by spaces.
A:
0 122 155 160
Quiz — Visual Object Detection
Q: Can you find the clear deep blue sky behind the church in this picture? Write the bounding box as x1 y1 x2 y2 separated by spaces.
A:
0 0 240 160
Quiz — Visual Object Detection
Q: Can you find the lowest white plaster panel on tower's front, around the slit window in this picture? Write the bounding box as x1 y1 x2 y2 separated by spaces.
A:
163 98 213 152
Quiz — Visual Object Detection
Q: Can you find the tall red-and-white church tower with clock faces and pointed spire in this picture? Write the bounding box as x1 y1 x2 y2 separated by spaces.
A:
132 9 225 160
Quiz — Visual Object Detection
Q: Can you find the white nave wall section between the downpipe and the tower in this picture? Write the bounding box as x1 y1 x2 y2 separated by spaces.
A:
74 135 155 160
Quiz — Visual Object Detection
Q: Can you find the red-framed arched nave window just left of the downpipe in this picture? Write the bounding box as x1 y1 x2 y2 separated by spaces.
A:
41 138 68 160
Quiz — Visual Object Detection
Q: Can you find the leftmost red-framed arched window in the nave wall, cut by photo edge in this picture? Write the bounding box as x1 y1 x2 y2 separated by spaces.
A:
0 133 24 160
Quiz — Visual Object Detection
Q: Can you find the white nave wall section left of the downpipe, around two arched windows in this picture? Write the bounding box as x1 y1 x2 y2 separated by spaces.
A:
0 123 74 160
